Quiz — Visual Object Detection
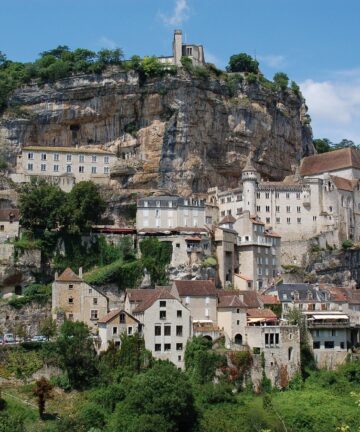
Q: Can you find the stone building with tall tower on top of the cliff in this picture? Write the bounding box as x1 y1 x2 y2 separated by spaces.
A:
158 30 205 66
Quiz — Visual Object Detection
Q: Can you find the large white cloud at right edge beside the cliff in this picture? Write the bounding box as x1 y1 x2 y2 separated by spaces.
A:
300 74 360 143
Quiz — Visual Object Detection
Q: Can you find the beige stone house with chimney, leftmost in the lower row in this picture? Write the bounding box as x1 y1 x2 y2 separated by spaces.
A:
52 267 109 331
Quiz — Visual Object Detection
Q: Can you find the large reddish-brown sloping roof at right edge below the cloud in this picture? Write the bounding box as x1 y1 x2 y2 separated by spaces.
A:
300 148 360 176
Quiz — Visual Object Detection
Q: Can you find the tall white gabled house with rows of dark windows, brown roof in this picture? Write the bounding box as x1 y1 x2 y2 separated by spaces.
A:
125 287 192 368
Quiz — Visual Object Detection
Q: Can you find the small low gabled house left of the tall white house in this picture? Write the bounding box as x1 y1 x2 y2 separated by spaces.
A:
97 309 142 351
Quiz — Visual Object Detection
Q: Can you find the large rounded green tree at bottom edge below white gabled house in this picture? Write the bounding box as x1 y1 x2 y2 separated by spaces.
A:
110 362 197 432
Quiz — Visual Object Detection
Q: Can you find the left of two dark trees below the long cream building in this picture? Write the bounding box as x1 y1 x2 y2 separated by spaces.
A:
19 181 66 232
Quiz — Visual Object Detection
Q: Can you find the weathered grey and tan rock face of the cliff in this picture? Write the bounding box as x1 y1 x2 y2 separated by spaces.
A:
0 70 314 195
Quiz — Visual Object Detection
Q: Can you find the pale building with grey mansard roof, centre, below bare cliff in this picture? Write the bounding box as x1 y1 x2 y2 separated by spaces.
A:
136 196 205 230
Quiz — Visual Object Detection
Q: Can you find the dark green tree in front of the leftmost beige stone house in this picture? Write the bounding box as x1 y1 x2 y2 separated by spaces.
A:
55 321 98 389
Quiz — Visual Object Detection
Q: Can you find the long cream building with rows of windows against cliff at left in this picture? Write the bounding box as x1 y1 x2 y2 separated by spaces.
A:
11 146 117 191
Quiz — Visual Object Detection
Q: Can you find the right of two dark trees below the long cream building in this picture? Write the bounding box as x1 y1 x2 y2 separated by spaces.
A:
65 181 106 234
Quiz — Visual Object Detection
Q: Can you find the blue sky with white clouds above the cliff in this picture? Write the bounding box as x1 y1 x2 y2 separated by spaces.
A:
0 0 360 144
